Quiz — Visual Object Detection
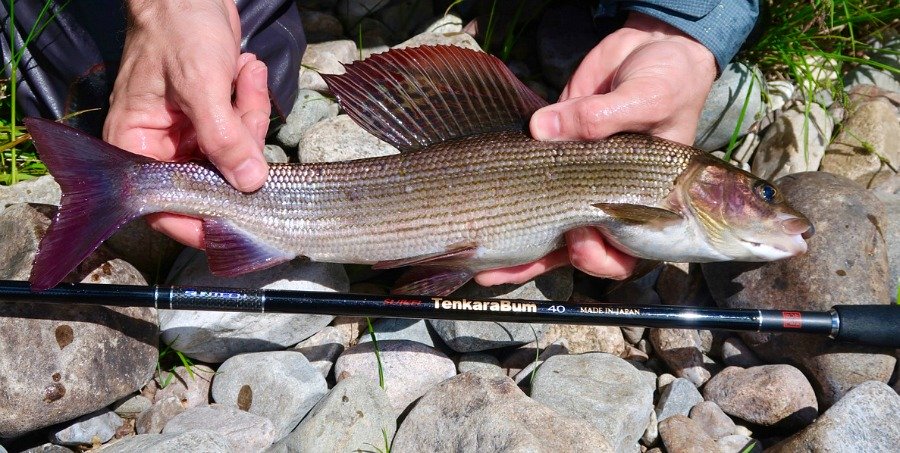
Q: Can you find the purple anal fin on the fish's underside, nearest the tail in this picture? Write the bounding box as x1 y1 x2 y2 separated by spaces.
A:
203 219 295 277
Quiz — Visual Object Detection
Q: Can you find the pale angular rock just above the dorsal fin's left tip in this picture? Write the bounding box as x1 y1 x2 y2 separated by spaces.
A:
297 40 359 92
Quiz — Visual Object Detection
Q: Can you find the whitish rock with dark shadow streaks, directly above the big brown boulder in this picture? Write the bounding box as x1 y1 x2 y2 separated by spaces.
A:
751 103 834 181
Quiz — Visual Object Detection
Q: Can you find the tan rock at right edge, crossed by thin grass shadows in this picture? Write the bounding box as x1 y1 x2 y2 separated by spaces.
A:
820 98 900 188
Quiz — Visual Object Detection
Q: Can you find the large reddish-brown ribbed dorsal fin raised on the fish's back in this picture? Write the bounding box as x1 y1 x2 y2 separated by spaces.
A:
323 46 547 151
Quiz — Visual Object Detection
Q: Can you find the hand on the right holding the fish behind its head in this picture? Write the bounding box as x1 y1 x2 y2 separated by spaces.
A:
476 13 716 285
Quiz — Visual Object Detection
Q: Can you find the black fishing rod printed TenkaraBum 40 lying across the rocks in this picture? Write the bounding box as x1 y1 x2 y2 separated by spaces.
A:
0 281 900 348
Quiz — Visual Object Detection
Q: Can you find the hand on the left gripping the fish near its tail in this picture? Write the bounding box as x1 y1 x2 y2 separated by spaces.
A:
103 0 271 247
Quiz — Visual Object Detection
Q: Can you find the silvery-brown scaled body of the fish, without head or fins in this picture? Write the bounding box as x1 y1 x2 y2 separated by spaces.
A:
135 132 697 263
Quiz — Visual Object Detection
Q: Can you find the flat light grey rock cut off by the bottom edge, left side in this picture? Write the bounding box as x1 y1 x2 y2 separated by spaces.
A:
102 429 231 453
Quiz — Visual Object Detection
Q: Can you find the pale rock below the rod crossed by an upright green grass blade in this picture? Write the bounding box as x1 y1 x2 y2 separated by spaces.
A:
334 340 456 415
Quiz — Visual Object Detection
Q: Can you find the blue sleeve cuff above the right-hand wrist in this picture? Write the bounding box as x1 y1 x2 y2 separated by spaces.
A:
598 0 759 71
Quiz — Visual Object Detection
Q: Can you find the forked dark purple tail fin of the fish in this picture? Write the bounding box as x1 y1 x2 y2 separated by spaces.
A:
25 118 153 291
